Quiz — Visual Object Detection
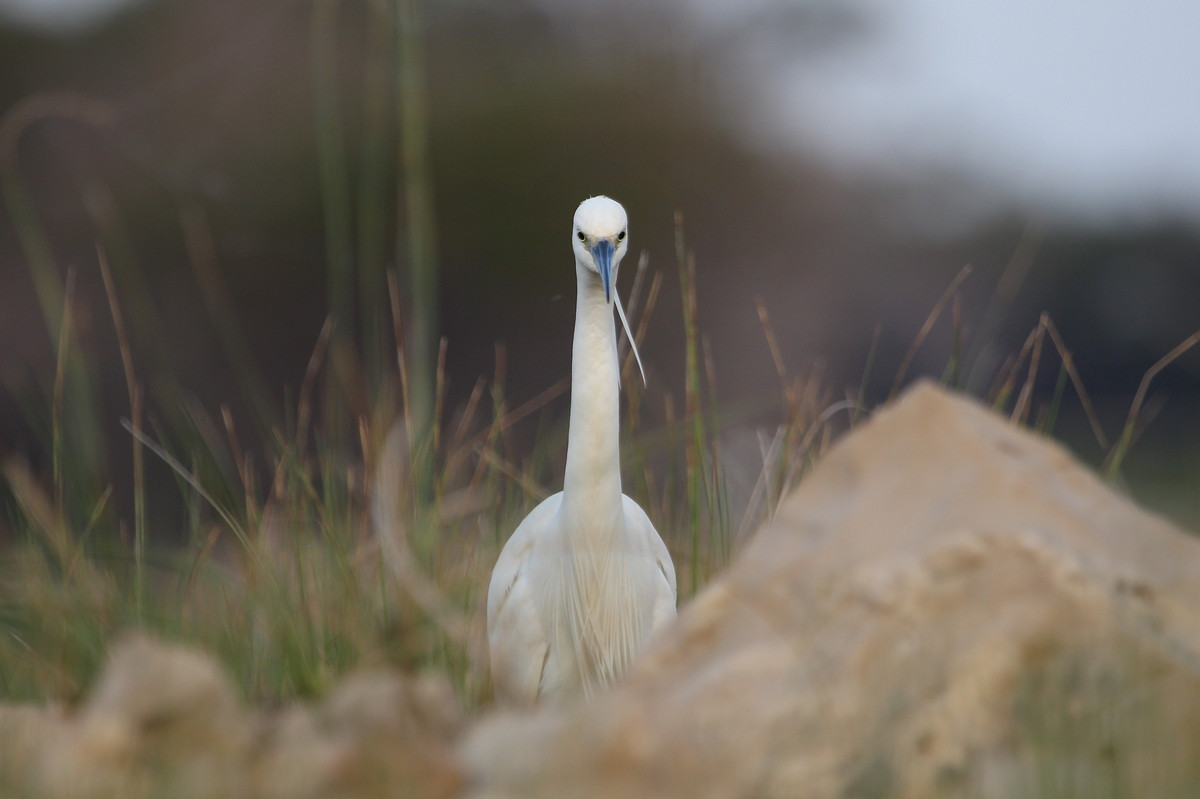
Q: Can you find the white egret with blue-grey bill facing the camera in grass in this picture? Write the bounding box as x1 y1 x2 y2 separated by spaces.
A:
487 197 676 704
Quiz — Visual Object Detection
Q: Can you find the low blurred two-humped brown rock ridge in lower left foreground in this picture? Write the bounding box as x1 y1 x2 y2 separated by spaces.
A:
0 633 461 799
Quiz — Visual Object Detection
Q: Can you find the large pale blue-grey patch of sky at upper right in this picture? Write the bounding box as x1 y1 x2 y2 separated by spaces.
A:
753 0 1200 220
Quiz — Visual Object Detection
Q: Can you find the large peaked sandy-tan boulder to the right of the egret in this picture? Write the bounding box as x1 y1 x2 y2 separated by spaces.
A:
461 384 1200 799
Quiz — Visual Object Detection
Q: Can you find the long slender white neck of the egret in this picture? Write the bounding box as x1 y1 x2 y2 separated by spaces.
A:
563 264 622 528
